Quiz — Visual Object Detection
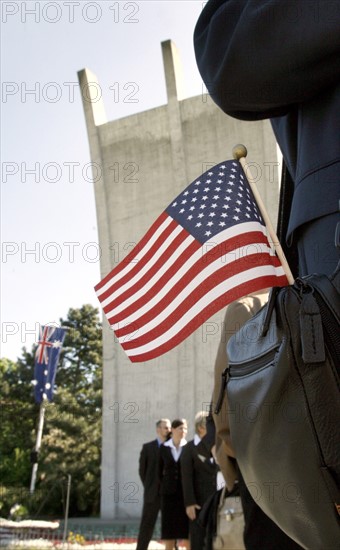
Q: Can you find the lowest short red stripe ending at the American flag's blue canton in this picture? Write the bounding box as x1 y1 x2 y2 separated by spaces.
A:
109 241 201 325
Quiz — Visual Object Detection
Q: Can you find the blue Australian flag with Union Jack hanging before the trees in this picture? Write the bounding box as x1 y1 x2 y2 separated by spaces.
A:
33 326 66 403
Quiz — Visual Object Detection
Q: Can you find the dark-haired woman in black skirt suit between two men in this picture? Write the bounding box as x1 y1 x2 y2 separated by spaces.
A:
159 418 189 550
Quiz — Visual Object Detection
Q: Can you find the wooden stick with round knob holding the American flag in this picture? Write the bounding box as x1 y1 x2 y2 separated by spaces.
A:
233 144 294 285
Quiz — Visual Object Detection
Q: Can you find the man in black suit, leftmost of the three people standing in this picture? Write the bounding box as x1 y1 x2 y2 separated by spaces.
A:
137 418 171 550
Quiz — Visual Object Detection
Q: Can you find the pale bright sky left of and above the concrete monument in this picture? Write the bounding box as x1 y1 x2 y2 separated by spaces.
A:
0 0 204 360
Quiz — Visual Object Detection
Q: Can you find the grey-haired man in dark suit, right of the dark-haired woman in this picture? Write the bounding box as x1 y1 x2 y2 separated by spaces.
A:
180 411 219 550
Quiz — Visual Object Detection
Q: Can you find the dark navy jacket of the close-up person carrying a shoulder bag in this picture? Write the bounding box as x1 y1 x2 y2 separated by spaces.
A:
194 0 340 275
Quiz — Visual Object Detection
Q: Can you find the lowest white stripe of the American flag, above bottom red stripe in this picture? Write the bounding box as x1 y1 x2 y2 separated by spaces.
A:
121 265 284 357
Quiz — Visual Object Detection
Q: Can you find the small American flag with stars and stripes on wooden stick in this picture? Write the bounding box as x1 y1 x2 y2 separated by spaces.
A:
95 160 287 362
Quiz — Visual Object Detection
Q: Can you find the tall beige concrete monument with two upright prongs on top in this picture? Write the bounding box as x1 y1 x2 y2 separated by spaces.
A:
79 41 278 519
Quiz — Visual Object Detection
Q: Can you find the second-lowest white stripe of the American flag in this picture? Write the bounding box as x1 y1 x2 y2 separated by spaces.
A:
113 243 269 336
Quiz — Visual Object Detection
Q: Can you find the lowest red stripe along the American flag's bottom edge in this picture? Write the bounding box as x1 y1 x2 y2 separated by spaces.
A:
122 275 287 363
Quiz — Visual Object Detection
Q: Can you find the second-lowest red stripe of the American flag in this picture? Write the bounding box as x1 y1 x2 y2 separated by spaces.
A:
115 254 277 350
